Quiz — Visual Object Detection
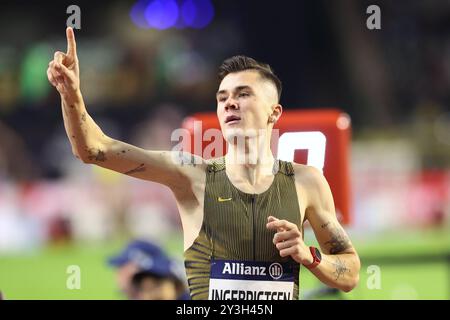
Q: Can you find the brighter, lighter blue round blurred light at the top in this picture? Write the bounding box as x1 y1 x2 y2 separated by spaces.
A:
144 0 179 30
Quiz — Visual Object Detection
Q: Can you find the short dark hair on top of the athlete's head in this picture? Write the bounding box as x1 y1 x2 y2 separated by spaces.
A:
219 55 282 100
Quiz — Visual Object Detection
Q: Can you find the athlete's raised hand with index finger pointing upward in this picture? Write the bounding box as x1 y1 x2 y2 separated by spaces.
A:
47 27 80 96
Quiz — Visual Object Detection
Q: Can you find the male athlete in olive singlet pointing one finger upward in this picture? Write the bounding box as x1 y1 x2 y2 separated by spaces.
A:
47 28 360 299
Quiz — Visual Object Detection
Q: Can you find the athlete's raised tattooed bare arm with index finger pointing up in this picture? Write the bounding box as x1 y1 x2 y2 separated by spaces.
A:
47 28 202 189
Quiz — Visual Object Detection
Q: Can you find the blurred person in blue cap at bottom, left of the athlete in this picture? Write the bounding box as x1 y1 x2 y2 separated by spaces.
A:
109 240 189 300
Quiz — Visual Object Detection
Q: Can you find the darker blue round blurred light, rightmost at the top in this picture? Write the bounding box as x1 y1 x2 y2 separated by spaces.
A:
181 0 214 29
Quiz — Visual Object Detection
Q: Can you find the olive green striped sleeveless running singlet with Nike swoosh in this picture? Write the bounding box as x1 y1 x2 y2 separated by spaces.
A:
184 158 302 300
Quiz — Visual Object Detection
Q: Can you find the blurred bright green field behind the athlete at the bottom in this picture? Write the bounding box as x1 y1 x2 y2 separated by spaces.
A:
0 230 450 299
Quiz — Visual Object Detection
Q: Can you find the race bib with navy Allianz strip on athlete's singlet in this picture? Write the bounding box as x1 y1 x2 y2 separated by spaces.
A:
208 260 294 300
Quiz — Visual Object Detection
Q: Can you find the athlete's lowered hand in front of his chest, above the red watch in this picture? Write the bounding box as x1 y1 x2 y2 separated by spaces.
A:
266 216 314 265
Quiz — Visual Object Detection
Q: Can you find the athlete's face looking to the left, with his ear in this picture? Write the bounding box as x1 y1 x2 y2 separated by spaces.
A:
217 70 281 141
